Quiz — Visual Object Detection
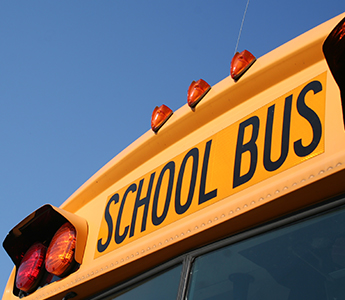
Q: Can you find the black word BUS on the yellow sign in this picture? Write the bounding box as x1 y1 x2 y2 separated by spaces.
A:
233 81 322 188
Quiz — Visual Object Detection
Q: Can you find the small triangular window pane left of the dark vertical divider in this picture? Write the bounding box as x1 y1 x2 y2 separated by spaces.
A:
106 265 182 300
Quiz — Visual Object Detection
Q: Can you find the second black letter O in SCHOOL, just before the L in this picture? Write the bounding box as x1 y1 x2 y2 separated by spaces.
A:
175 148 199 215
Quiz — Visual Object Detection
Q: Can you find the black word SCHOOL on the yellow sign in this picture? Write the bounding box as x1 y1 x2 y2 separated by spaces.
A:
97 140 217 252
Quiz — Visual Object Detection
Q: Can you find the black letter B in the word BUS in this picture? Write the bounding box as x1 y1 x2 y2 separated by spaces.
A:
232 116 260 188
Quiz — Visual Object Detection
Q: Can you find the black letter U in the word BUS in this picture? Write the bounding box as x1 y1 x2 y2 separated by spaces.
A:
264 95 292 171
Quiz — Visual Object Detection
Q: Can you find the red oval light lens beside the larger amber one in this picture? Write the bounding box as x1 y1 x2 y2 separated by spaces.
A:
16 243 47 292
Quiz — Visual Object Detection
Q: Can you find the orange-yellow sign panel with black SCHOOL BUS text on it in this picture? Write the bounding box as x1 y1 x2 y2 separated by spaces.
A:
95 74 326 257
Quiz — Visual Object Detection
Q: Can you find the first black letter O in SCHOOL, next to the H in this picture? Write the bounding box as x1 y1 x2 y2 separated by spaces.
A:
152 161 175 226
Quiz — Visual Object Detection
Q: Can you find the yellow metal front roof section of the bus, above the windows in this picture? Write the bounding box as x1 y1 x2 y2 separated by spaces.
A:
3 10 345 299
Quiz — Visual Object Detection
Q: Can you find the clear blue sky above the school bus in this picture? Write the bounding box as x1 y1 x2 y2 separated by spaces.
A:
0 0 345 291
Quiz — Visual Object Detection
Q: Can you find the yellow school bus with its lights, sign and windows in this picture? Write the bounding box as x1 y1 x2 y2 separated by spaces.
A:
3 14 345 300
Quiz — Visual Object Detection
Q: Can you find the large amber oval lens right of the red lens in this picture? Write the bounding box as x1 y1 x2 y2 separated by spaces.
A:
45 223 76 276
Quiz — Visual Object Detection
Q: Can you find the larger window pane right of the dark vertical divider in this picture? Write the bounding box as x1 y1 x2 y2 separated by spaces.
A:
187 205 345 300
